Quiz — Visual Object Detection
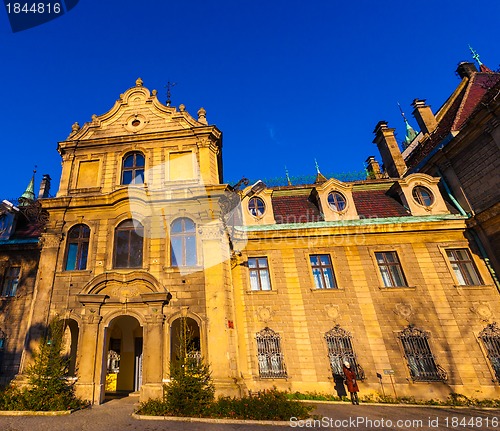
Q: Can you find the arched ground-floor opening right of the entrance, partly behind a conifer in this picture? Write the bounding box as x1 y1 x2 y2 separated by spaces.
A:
170 317 201 362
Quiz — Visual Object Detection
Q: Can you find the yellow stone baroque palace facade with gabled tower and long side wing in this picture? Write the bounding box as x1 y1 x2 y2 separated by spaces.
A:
0 75 500 403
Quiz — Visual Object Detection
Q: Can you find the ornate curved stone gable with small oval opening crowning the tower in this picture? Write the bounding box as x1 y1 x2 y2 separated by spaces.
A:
67 78 206 141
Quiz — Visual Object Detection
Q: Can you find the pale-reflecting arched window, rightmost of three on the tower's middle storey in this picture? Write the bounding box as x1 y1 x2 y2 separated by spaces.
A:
170 217 196 266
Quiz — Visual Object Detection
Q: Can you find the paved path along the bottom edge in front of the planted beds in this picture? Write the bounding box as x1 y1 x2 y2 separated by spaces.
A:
0 397 500 431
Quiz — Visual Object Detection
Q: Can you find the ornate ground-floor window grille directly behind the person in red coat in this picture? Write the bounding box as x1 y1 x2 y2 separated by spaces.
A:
325 325 365 380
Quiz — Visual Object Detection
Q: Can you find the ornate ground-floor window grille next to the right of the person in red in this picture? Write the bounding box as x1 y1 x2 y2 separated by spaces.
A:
399 325 448 382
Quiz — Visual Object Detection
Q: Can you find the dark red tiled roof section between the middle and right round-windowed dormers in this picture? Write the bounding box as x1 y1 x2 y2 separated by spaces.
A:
352 190 411 218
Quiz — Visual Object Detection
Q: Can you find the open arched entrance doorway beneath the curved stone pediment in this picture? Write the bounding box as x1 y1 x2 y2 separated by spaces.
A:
104 316 143 396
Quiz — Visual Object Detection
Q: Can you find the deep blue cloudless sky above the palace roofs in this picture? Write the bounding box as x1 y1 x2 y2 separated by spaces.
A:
0 0 500 199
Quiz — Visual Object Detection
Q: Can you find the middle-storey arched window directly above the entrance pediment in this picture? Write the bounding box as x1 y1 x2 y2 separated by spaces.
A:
114 220 144 268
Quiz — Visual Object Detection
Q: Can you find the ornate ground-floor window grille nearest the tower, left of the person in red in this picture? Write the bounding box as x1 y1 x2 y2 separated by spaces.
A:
255 327 288 379
